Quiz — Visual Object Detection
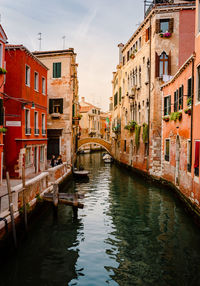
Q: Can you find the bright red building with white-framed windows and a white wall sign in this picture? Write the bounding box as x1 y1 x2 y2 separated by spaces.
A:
4 45 47 177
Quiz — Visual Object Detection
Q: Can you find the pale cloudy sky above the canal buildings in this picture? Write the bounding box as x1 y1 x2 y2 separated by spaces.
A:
0 0 144 111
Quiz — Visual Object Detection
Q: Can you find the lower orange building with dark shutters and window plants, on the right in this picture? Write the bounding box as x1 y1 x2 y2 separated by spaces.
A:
162 55 195 197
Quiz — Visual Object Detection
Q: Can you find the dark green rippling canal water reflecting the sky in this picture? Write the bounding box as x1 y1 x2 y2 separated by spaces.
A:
0 153 200 286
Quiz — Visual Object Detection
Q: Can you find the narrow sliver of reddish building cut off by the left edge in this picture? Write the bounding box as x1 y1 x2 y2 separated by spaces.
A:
0 25 7 182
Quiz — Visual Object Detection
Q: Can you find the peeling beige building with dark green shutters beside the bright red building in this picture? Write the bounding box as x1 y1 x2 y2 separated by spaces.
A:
34 48 79 164
